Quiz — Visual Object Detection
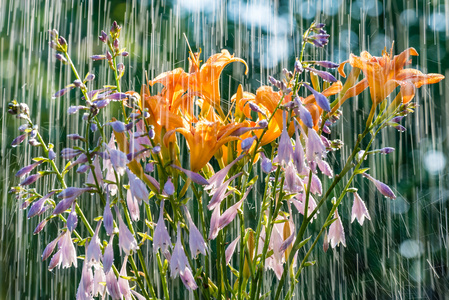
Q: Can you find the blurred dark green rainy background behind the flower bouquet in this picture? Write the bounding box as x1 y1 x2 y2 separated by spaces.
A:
0 0 449 299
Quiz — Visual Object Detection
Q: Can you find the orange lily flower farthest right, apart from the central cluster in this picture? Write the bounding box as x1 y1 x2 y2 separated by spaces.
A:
339 47 444 106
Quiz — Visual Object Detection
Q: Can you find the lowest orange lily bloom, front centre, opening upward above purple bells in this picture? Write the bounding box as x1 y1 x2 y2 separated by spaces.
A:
164 119 246 172
